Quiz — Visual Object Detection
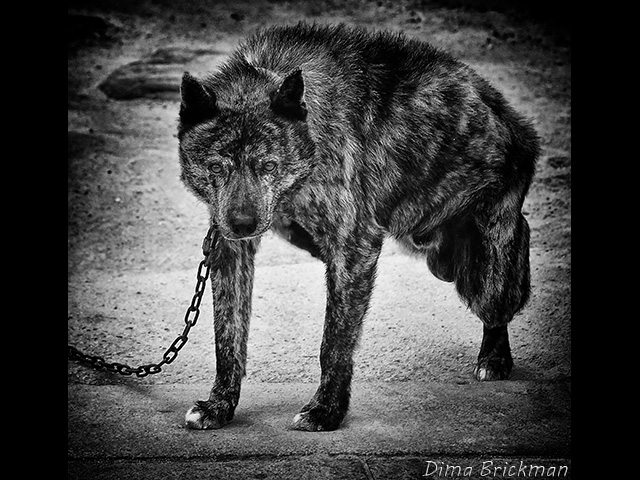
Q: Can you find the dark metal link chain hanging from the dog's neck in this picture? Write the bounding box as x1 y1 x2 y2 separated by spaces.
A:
67 225 218 377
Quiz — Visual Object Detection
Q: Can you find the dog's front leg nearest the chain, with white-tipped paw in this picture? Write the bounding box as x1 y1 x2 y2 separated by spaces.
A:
185 237 259 429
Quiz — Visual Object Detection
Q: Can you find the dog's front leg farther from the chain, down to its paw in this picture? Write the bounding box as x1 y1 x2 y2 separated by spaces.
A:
292 236 382 431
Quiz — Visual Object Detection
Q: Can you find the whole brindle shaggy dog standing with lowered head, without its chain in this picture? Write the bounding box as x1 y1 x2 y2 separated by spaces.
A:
178 24 539 431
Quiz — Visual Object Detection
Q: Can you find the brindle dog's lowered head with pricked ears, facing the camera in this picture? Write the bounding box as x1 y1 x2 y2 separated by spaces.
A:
178 69 315 240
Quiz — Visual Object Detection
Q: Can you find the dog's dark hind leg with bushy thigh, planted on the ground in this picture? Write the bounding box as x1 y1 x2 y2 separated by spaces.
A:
455 193 530 380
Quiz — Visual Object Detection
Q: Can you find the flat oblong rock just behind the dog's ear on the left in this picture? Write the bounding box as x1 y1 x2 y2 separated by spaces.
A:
99 46 226 100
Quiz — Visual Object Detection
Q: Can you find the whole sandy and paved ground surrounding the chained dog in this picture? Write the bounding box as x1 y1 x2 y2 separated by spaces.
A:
67 0 572 480
